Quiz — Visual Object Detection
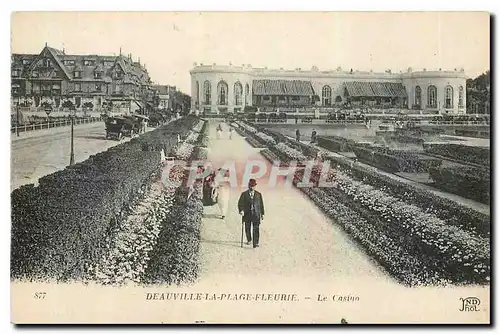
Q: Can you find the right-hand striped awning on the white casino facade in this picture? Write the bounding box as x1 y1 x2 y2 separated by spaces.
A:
344 81 407 98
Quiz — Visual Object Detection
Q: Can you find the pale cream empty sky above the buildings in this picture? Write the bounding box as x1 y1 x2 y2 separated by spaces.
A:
11 12 490 94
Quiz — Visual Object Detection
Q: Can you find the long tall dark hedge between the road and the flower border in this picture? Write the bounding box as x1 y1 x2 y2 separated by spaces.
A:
11 117 197 281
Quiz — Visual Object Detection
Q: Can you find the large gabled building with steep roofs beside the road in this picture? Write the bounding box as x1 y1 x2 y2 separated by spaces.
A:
11 45 153 112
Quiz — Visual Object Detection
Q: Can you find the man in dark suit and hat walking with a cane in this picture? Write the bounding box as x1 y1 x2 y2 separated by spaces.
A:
238 179 264 248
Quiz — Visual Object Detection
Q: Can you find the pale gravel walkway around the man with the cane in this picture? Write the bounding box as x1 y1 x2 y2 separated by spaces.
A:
196 123 394 283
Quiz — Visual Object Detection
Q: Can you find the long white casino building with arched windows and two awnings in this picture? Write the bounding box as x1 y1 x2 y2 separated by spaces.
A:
190 63 467 115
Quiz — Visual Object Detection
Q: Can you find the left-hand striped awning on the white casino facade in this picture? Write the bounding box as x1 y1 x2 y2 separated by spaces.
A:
252 80 314 96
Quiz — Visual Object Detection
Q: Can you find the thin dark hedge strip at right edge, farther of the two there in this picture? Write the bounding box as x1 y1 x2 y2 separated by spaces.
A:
424 144 490 167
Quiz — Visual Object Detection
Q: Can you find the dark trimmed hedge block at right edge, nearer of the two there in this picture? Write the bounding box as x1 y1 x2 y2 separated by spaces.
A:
430 166 491 204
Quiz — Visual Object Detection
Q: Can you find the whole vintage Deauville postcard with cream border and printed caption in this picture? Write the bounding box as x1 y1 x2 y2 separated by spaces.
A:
10 12 491 324
